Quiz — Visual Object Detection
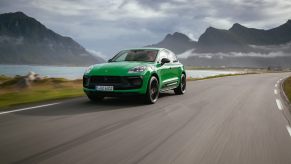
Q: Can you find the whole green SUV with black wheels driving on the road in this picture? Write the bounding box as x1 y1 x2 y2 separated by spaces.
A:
83 48 186 104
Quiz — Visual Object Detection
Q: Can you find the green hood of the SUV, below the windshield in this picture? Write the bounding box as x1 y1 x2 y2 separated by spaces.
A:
89 62 151 76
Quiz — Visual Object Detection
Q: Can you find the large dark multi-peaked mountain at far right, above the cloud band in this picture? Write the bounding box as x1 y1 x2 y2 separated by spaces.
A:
197 20 291 52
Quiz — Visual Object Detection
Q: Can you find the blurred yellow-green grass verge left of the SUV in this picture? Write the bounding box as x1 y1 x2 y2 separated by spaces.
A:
0 78 84 109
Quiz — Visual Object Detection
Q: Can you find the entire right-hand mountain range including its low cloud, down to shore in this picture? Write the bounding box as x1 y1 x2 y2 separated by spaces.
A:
151 20 291 68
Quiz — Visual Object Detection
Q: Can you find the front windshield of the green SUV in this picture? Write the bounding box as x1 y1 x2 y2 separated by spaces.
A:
111 50 158 62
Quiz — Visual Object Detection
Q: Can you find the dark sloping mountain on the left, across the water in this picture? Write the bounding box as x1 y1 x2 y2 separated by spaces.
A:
0 12 104 65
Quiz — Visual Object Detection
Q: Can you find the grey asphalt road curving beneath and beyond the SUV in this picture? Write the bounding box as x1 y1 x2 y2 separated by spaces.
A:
0 73 291 164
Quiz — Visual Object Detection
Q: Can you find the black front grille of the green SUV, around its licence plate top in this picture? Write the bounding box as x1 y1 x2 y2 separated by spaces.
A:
83 76 143 90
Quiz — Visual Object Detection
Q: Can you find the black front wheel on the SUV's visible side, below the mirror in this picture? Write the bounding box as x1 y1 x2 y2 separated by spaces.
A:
145 76 160 104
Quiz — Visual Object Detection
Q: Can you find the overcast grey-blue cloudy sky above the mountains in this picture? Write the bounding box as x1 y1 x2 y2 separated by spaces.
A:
0 0 291 56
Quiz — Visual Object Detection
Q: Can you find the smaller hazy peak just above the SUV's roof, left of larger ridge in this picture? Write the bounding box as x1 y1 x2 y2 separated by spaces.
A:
146 32 197 54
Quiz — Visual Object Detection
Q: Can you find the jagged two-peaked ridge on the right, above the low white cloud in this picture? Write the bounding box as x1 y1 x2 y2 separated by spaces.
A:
150 20 291 54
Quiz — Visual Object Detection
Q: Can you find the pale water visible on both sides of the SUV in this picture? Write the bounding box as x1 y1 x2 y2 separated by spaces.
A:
0 65 238 79
